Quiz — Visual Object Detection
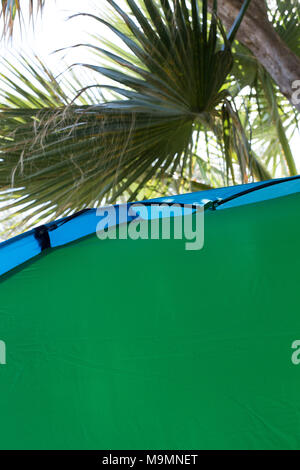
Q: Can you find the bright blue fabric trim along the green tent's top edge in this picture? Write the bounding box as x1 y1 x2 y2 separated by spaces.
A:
0 175 300 276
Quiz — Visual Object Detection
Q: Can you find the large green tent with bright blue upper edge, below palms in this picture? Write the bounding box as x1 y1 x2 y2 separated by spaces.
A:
0 177 300 450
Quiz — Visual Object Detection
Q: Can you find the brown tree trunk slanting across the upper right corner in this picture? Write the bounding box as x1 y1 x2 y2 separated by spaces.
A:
210 0 300 111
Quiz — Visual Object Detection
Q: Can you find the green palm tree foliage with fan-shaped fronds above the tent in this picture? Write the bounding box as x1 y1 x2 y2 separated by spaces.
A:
0 0 300 235
